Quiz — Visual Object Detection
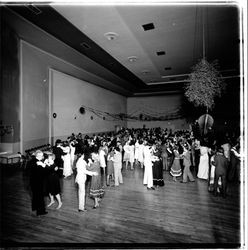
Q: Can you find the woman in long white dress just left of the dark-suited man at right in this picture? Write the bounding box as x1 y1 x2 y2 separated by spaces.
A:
197 145 209 180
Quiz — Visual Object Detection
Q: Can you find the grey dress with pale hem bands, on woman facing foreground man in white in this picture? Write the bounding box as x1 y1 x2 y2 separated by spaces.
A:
87 161 104 199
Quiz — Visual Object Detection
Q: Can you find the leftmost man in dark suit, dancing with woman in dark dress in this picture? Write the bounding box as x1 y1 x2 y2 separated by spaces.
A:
30 150 47 216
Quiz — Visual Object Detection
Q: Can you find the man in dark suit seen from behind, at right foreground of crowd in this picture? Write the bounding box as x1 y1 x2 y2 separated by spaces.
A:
212 148 228 198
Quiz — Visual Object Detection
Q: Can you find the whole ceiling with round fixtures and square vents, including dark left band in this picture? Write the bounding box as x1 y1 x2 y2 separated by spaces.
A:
4 4 240 96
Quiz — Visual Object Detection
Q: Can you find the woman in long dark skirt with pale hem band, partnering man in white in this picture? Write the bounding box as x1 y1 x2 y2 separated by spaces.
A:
152 144 164 187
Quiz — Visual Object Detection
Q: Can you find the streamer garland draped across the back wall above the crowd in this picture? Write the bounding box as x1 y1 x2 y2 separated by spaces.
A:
82 105 183 122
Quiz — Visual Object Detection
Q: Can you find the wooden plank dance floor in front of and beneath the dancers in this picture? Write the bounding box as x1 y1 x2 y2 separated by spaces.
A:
0 163 240 247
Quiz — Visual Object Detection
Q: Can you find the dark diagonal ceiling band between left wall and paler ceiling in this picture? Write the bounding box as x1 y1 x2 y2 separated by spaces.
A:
8 4 145 92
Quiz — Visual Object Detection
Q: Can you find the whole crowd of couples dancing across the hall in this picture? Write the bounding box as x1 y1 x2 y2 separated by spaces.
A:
30 128 240 215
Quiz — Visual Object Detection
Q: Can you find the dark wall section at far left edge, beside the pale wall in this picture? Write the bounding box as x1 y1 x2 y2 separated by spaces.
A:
0 21 20 143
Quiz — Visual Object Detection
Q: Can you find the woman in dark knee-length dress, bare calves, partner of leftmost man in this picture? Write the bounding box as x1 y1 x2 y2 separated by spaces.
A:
44 154 62 209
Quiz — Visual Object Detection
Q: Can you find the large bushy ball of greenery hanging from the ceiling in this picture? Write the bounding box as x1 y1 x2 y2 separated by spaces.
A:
185 58 226 113
